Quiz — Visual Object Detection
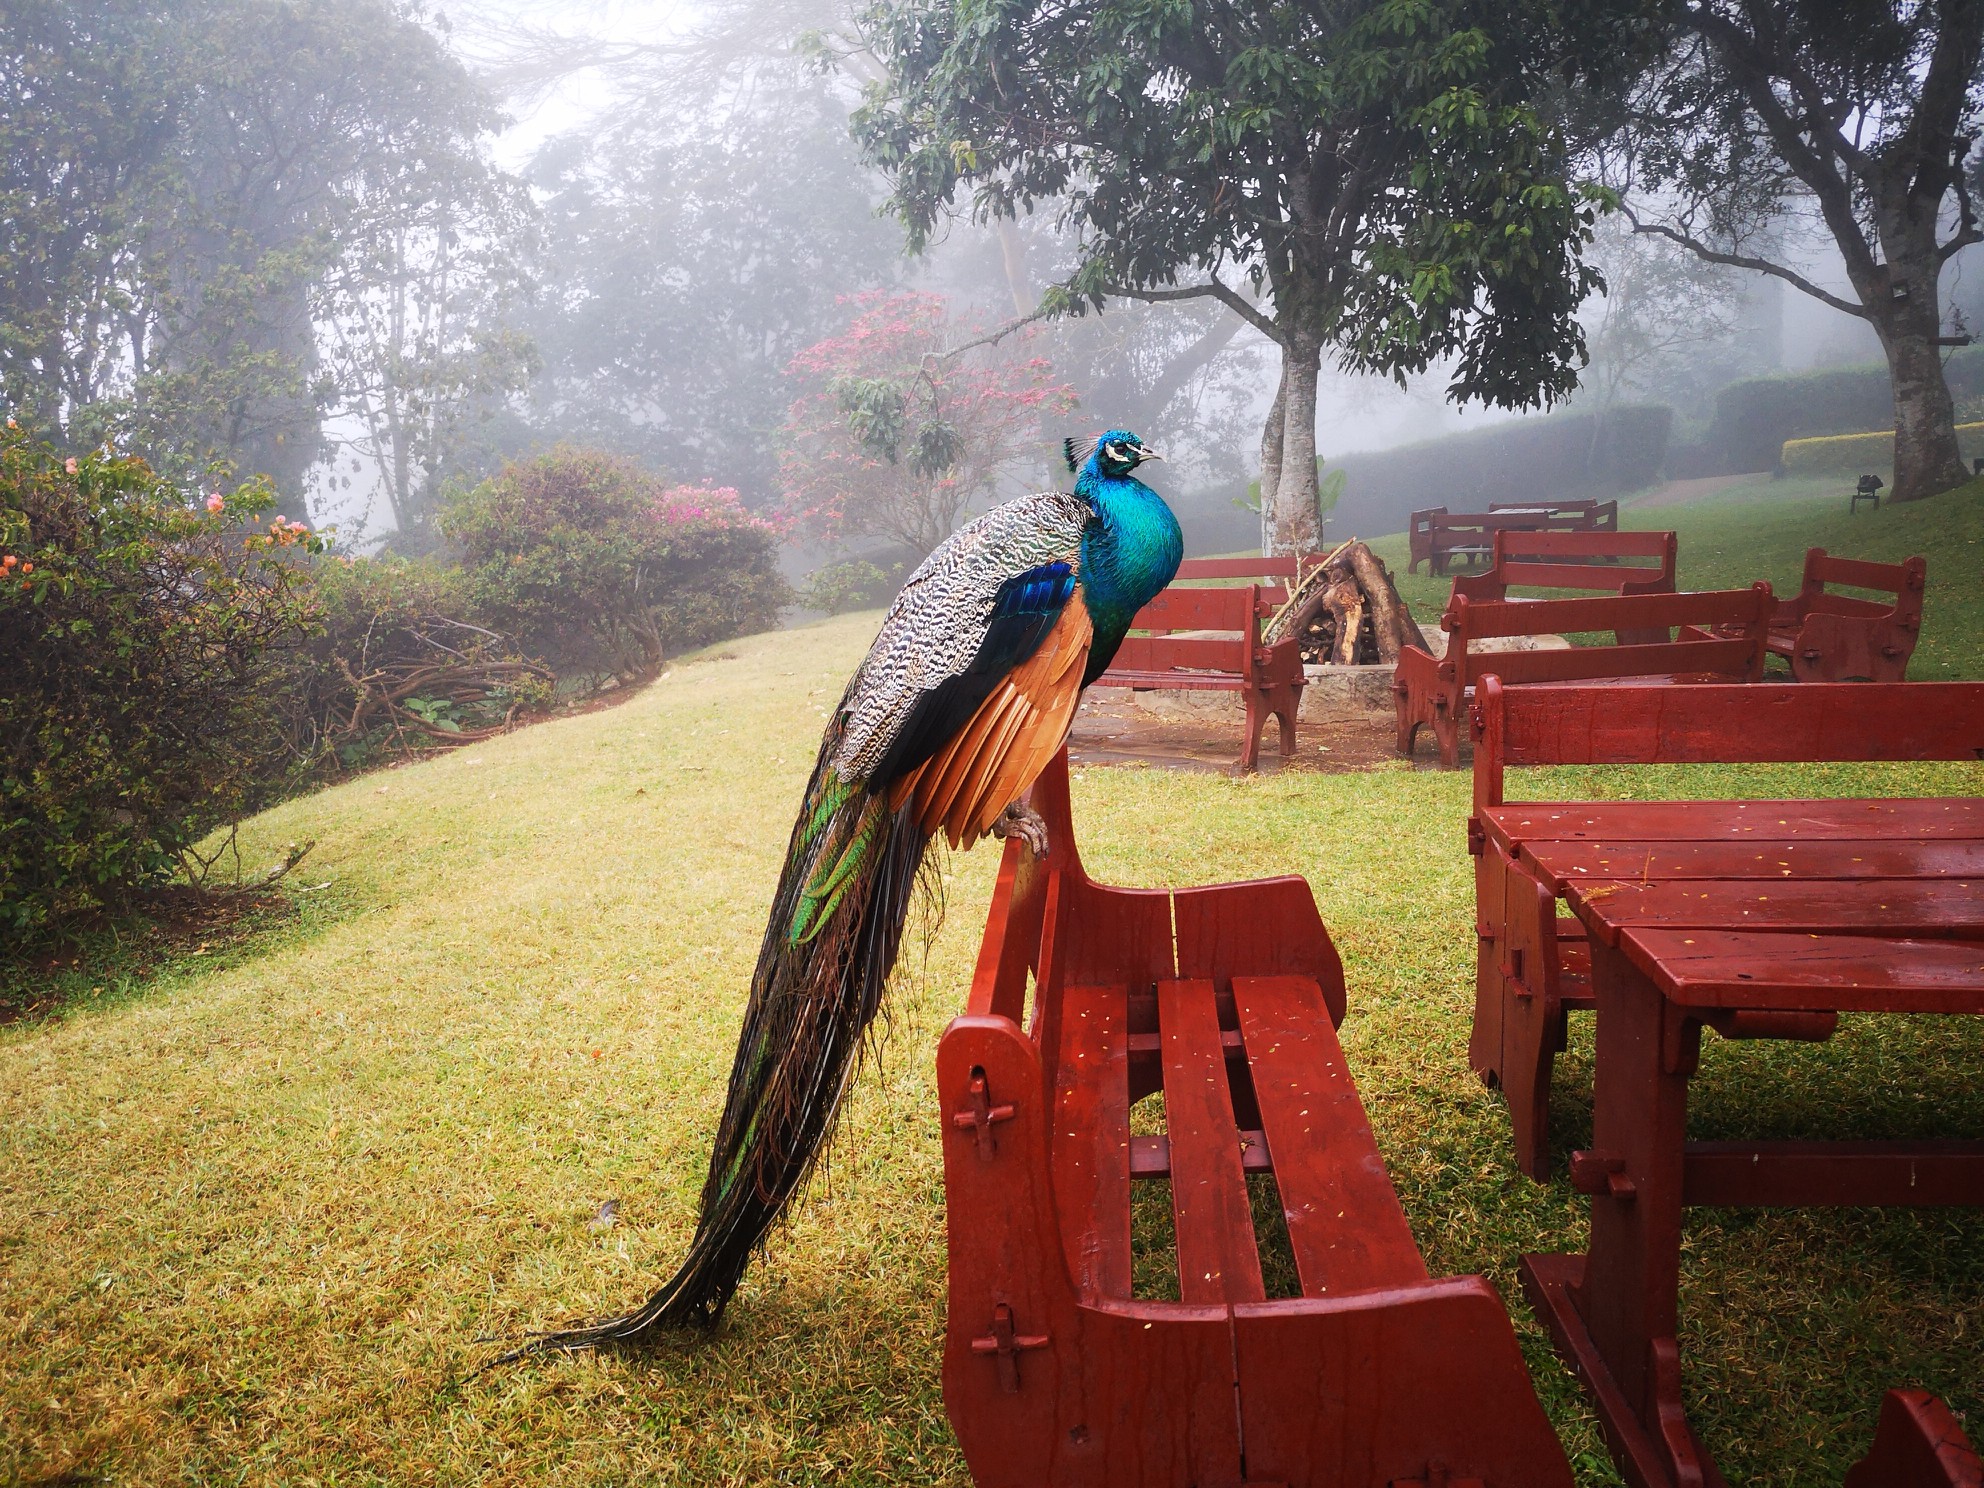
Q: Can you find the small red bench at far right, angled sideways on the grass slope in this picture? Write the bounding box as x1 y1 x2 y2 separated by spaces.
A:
1770 548 1928 682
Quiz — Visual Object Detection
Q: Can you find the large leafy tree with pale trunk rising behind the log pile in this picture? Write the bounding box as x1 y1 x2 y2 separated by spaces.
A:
857 0 1597 550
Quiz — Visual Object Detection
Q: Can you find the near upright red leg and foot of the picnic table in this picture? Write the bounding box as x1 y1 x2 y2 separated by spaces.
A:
1524 940 1722 1488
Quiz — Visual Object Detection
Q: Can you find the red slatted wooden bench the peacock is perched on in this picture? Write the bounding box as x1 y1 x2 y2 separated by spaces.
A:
936 754 1571 1488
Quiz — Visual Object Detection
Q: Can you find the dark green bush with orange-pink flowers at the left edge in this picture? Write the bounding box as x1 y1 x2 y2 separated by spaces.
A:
0 421 321 936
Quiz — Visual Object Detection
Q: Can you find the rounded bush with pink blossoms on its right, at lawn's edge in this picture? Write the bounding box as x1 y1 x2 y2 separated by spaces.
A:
440 446 792 679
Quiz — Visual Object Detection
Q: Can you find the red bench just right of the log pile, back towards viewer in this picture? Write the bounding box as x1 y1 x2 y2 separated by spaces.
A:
1391 583 1772 770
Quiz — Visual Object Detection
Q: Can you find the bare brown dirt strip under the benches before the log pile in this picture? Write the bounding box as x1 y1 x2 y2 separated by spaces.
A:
1067 692 1399 776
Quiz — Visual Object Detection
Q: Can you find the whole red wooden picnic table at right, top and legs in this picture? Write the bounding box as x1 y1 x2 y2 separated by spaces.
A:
1480 798 1984 1488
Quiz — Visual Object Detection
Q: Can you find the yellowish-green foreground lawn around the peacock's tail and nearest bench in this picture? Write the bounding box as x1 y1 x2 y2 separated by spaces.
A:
0 607 1984 1486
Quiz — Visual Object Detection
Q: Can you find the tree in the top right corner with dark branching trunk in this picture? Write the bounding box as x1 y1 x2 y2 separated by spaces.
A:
1605 0 1984 500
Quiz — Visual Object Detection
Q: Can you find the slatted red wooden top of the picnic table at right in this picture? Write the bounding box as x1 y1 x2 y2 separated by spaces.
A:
1484 796 1984 1012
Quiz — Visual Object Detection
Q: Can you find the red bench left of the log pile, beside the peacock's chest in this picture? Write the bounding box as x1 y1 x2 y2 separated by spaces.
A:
1095 575 1305 772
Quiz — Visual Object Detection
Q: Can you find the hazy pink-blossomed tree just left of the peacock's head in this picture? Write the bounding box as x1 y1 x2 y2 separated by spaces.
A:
780 294 1073 558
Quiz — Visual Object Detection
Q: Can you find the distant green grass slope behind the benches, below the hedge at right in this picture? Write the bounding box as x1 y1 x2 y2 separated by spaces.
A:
1364 476 1984 682
